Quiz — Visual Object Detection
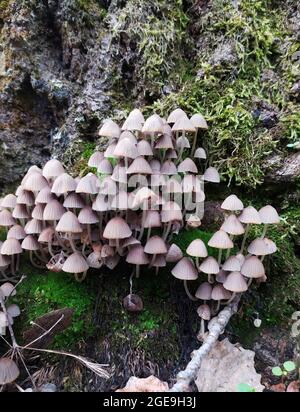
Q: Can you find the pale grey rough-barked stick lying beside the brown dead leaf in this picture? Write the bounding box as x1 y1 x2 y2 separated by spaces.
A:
170 297 240 392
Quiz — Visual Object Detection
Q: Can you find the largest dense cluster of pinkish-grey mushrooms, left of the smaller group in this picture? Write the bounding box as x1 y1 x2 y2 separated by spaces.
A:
0 109 214 290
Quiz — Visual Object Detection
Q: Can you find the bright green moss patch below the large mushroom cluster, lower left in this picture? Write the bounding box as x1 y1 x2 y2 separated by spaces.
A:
15 262 96 349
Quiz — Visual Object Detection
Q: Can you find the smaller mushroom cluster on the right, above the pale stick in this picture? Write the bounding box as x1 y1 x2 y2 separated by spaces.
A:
171 195 280 338
